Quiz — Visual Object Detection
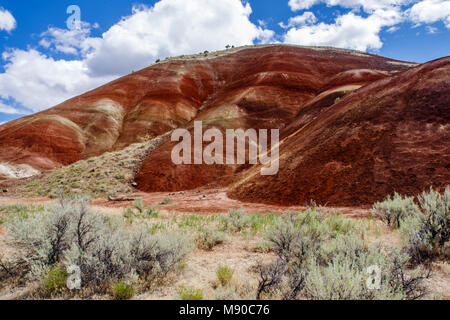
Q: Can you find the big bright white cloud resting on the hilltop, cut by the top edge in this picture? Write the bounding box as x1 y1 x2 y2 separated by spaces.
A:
86 0 274 75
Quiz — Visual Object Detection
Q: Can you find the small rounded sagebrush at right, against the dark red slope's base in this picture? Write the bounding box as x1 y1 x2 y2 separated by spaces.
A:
372 193 421 229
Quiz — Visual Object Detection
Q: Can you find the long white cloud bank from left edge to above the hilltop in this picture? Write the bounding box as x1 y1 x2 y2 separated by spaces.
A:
0 0 274 113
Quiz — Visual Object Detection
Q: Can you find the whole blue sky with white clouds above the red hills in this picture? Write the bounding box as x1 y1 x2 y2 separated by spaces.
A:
0 0 450 123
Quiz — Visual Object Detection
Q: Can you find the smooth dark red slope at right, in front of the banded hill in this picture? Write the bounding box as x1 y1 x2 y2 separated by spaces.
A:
229 58 450 206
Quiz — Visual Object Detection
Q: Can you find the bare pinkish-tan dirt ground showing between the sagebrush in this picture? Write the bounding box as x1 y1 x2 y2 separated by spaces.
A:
0 189 450 300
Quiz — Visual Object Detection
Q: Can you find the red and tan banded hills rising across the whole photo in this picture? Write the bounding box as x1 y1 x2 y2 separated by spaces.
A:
0 45 450 205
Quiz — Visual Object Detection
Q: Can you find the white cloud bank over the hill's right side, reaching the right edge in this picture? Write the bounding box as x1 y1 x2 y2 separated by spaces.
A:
281 0 444 51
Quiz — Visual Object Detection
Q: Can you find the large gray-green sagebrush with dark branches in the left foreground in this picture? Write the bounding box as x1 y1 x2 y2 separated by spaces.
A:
4 198 193 296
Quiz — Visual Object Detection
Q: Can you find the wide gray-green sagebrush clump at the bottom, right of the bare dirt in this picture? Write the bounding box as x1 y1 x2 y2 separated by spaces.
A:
257 209 427 300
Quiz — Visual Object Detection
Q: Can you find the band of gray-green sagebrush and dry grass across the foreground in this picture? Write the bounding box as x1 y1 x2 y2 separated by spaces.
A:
0 191 444 300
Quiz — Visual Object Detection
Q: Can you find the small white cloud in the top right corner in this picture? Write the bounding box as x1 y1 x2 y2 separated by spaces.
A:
409 0 450 29
